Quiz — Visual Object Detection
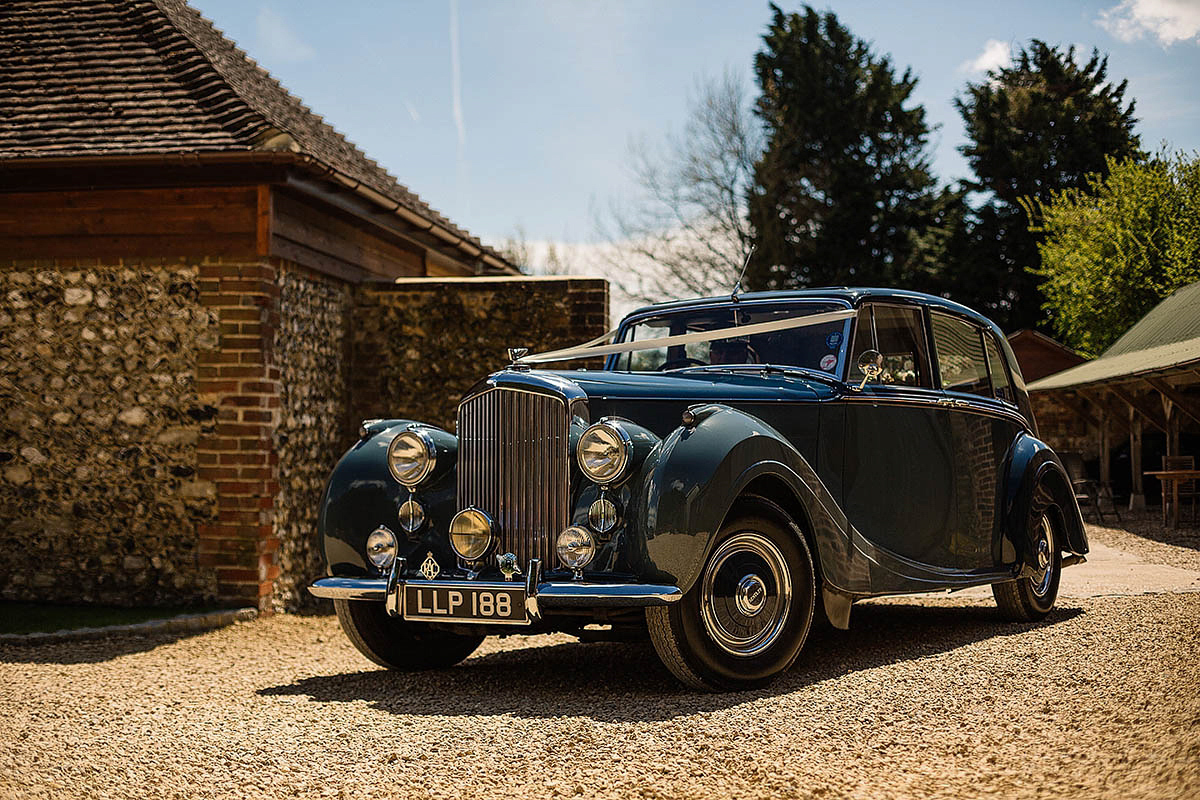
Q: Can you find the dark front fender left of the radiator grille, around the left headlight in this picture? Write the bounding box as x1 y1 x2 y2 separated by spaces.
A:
317 420 457 578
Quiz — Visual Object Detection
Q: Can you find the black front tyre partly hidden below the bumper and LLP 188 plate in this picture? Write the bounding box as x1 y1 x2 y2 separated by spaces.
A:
334 600 484 672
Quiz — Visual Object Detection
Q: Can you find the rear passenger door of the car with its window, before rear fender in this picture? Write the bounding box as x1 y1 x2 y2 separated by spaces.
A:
930 311 1025 569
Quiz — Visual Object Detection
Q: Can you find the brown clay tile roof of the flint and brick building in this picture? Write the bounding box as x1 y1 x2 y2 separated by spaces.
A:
0 0 511 268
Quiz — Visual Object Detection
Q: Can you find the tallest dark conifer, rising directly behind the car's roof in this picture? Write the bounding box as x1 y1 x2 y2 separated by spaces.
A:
746 5 935 289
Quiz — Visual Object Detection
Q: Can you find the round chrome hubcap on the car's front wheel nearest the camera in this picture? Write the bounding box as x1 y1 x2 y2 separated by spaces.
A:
700 531 792 657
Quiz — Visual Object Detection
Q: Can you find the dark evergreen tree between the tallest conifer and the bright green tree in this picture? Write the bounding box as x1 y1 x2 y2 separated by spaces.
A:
947 40 1141 330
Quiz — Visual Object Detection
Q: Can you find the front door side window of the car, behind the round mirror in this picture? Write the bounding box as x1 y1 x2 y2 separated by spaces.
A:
848 305 934 387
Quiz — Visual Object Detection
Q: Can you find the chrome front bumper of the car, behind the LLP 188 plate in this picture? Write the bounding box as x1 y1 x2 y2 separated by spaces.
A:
308 560 683 620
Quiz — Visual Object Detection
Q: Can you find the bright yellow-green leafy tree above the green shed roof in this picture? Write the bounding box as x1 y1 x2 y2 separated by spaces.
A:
1031 154 1200 355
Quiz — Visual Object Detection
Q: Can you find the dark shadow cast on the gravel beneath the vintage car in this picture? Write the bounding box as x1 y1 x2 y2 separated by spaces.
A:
258 604 1084 722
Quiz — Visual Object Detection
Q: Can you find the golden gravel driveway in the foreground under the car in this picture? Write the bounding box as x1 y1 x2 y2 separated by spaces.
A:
0 522 1200 800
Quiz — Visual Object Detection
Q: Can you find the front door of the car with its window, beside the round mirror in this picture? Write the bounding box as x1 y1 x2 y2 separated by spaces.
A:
842 303 973 569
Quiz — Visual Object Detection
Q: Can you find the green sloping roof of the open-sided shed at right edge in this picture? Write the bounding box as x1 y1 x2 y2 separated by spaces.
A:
1030 282 1200 391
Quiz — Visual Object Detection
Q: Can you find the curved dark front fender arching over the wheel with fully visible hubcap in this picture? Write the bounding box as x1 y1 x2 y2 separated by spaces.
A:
630 405 850 599
